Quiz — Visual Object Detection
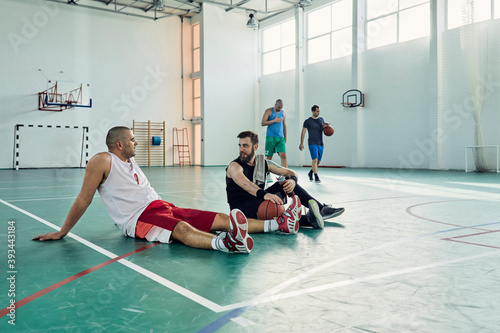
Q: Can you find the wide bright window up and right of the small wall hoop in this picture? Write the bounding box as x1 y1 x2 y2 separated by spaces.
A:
366 0 430 49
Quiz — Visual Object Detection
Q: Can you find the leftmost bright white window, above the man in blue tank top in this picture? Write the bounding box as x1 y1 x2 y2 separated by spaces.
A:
262 20 295 75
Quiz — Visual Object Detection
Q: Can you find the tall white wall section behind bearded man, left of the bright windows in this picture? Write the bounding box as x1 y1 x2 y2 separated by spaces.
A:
202 3 257 165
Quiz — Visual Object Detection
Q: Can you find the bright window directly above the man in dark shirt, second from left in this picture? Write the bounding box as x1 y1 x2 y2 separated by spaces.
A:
307 0 352 64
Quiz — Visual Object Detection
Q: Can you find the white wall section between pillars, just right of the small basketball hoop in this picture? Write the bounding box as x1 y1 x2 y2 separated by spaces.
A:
358 38 433 169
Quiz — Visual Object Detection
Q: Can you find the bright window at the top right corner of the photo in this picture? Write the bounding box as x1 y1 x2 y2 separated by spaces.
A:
447 0 500 29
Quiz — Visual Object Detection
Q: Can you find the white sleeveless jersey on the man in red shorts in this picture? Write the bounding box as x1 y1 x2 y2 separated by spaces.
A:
97 152 161 237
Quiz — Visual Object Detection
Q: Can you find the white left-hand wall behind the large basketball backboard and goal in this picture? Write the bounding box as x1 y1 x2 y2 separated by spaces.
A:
0 0 190 168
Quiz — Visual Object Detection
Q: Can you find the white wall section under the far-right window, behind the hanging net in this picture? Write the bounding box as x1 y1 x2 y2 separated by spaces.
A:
438 20 500 169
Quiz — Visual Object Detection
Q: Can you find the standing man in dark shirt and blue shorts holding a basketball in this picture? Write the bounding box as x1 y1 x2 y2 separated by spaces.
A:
299 105 329 183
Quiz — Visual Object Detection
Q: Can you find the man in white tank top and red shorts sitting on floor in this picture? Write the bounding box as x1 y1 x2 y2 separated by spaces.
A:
33 126 300 253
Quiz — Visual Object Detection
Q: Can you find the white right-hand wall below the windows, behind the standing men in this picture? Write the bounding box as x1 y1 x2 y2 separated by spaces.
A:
259 6 500 170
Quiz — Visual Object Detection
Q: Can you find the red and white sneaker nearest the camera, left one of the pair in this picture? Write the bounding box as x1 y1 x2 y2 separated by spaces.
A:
222 209 253 253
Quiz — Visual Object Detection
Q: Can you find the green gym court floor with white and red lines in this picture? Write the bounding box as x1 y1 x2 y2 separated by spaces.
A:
0 167 500 332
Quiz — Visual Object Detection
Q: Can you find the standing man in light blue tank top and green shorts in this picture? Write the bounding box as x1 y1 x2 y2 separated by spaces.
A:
261 99 288 168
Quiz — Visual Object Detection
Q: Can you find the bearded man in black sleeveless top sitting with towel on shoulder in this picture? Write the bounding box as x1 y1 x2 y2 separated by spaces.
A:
226 131 344 229
